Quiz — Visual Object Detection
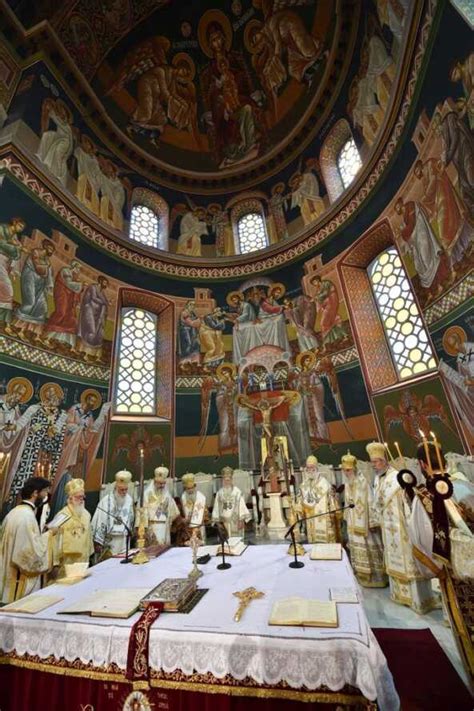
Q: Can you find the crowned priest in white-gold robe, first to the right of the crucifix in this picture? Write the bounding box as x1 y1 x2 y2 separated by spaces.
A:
297 455 339 543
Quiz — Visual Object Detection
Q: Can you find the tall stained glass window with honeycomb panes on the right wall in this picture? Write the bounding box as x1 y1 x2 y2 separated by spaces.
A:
368 247 436 380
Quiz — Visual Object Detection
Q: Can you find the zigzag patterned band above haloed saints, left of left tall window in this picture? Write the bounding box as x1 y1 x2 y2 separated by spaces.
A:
0 336 110 386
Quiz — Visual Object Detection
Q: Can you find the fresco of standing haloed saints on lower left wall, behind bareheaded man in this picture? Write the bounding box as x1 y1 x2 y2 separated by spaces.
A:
0 363 110 510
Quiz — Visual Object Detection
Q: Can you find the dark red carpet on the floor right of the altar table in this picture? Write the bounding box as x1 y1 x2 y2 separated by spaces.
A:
373 627 474 711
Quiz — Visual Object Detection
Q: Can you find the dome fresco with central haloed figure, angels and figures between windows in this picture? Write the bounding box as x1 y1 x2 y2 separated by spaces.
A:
1 0 412 262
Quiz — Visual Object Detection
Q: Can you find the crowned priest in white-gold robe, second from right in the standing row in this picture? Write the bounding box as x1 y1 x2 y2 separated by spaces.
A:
341 452 388 588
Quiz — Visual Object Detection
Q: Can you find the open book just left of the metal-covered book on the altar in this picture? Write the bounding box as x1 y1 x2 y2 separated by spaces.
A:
57 588 150 619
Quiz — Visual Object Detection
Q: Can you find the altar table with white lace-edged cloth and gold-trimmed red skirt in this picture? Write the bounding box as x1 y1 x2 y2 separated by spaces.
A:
0 545 399 711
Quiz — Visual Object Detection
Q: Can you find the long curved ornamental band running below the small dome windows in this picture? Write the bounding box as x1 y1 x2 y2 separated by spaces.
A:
0 0 438 280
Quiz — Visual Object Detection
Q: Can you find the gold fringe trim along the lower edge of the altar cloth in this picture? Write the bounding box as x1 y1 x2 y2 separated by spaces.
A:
0 655 373 708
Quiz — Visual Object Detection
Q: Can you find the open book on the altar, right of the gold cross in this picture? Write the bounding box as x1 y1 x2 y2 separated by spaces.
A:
268 597 338 627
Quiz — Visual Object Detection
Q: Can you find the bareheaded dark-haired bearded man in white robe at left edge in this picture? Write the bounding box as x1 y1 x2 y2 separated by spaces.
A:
0 477 56 603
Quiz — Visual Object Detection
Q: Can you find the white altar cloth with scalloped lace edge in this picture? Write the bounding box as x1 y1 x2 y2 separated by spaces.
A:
0 545 399 711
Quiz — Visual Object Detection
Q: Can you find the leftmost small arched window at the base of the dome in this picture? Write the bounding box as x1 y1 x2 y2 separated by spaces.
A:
128 188 168 249
